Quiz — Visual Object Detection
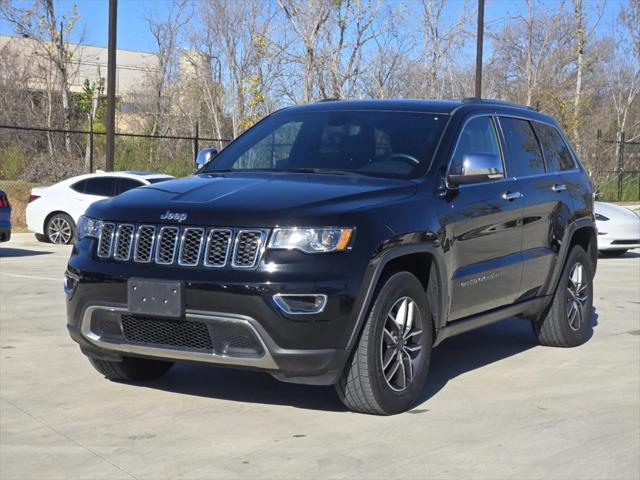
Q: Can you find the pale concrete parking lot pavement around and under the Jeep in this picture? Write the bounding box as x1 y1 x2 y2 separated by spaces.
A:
0 234 640 480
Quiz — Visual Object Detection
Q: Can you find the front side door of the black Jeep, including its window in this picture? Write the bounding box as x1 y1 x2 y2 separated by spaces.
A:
443 114 523 320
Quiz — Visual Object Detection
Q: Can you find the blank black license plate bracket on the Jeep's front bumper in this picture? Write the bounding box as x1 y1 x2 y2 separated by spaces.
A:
127 278 184 318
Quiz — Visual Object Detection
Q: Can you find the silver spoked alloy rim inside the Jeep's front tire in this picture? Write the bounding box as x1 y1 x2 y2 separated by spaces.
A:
380 297 422 392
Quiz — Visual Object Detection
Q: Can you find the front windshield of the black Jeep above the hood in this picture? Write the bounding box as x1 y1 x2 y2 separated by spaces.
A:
201 111 446 178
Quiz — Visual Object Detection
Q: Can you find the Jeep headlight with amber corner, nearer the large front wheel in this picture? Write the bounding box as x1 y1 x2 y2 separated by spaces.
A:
269 227 353 253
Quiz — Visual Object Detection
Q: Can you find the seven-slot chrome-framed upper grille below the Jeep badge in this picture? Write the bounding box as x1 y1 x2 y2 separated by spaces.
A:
96 223 267 269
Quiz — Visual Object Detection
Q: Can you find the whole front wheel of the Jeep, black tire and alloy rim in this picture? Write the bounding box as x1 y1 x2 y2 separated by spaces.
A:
336 272 433 415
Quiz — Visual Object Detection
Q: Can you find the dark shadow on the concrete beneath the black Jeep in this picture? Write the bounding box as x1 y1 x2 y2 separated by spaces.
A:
144 309 598 412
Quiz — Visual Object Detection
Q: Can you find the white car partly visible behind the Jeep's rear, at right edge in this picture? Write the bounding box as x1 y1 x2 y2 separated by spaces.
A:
595 202 640 256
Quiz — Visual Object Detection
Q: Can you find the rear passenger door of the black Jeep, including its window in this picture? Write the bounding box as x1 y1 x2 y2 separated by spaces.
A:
500 116 571 300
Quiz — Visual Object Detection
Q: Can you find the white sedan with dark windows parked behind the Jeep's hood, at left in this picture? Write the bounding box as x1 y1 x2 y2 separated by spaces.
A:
27 171 174 244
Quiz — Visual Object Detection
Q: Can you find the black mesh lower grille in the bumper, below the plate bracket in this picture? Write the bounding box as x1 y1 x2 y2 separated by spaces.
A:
122 315 213 353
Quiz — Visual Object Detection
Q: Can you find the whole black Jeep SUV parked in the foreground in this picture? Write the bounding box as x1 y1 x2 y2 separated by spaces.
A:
65 99 597 414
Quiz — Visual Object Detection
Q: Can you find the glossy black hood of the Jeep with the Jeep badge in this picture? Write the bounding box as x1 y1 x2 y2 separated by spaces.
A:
87 172 416 227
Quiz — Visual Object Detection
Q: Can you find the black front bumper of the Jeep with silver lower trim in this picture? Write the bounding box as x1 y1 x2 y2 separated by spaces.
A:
67 240 366 385
